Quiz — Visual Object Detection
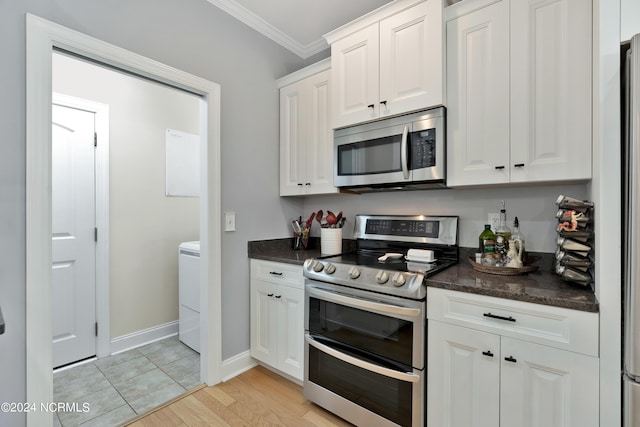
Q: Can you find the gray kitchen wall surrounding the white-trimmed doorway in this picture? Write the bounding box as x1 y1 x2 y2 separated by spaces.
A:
0 0 306 426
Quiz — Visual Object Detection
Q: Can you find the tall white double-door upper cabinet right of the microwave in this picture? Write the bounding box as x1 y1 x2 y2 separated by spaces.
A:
447 0 592 187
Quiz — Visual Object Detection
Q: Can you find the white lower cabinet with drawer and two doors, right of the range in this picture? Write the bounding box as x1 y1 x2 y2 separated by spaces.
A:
427 288 599 427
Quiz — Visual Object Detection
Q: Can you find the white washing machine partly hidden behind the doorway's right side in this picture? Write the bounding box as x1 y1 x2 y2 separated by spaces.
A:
178 242 200 353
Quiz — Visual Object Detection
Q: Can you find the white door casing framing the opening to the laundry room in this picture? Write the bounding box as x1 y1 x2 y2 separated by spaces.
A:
26 15 222 426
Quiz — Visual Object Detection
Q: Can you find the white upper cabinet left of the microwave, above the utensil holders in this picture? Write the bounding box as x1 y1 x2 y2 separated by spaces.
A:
278 60 338 196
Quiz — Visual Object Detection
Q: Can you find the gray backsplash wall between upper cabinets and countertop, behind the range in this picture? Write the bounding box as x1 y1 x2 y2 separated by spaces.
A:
300 184 597 253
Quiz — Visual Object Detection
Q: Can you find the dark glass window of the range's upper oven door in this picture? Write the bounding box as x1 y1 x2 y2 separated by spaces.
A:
308 297 413 367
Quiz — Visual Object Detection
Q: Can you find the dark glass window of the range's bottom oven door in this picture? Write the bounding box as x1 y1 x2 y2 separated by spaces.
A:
308 346 413 426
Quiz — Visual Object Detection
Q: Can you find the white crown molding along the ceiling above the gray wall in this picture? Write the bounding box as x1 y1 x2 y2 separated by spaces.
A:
207 0 329 59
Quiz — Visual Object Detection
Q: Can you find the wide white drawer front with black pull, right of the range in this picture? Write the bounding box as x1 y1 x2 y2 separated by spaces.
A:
427 288 598 357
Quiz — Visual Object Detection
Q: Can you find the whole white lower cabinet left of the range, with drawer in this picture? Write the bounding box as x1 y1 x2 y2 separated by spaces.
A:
251 260 304 381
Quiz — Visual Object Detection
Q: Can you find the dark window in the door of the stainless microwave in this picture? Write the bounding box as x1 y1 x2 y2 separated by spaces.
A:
338 135 402 175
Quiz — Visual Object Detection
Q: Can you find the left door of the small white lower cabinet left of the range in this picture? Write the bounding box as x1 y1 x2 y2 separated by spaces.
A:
251 280 277 366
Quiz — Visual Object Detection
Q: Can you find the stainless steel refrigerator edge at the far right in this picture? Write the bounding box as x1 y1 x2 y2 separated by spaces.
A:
622 34 640 427
